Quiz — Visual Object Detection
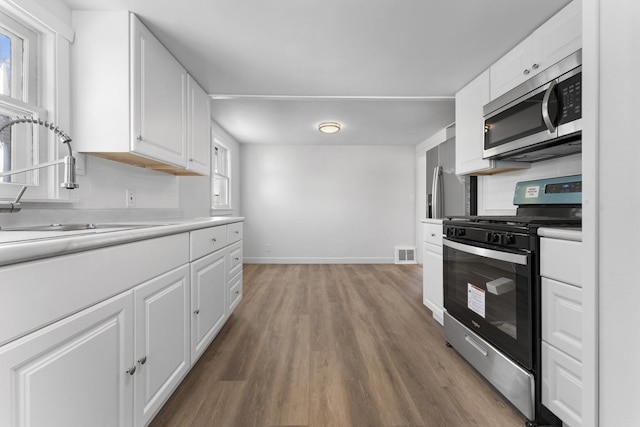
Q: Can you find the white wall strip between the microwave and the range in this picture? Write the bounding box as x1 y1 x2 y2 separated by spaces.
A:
478 154 582 215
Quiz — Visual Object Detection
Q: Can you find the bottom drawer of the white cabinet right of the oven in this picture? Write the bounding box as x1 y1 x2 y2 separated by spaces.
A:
542 342 582 427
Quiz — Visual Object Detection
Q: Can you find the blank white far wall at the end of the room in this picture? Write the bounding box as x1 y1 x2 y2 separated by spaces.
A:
241 145 415 263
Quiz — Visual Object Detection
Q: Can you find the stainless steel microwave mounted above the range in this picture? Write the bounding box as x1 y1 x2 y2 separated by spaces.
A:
483 50 582 162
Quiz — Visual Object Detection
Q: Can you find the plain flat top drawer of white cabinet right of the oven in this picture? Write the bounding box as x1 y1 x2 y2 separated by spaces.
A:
540 238 582 286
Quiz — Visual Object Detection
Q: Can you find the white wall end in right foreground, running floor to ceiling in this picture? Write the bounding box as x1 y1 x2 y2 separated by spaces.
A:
584 0 640 427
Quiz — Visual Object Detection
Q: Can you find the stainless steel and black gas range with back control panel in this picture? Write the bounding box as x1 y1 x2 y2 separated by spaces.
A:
443 175 582 426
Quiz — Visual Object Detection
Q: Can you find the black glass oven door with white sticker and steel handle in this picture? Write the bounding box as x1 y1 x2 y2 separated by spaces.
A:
443 238 533 370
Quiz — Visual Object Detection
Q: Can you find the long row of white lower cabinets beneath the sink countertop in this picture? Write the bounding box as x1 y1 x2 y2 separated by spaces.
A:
0 223 242 427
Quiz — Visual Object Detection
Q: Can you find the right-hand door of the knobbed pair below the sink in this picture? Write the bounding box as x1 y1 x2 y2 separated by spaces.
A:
134 265 191 426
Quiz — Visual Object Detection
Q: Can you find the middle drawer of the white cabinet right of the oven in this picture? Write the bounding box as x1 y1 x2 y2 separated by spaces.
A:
542 277 582 361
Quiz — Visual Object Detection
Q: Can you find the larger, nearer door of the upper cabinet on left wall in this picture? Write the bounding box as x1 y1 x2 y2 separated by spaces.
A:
131 15 187 168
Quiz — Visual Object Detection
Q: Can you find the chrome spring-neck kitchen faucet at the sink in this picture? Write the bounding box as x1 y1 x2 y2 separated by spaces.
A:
0 116 78 213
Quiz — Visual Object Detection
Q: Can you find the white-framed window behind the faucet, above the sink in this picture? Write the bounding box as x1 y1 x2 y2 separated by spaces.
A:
0 1 77 201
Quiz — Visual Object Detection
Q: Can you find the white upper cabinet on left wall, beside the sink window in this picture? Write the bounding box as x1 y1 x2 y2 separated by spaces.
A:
71 11 209 175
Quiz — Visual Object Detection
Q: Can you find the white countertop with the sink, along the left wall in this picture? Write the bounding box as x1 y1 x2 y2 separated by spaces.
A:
0 217 244 265
